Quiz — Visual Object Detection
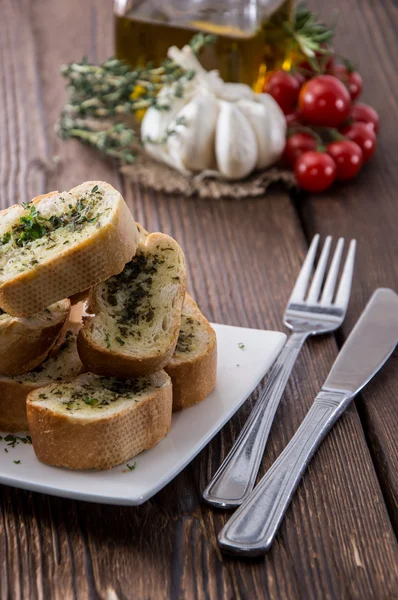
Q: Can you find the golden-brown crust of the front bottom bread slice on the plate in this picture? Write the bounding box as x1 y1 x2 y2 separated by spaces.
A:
27 373 172 469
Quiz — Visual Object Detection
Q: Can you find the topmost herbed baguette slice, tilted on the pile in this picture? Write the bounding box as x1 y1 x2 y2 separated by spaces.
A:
0 181 138 317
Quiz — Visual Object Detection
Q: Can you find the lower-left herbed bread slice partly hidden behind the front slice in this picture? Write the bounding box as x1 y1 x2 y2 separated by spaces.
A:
0 328 84 432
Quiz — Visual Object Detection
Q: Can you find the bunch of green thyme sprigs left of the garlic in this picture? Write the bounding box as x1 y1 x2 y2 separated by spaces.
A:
56 33 215 162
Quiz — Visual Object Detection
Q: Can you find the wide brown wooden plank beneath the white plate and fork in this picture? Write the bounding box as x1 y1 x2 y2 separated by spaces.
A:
0 0 398 600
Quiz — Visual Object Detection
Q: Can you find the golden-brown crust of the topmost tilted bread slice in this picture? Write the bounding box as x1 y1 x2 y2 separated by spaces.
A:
0 181 139 317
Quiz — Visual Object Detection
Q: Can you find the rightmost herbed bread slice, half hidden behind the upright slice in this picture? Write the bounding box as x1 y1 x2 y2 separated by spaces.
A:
165 294 217 411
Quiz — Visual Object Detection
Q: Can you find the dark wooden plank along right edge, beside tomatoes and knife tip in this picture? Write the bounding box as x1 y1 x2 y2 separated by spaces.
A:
298 0 398 532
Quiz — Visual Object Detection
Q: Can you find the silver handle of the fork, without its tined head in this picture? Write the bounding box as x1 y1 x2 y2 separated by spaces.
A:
203 332 308 508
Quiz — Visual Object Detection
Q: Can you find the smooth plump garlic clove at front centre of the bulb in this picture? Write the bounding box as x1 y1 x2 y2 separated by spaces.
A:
215 100 258 179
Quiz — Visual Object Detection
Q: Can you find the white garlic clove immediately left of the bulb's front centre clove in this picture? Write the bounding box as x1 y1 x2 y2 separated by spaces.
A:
167 90 218 171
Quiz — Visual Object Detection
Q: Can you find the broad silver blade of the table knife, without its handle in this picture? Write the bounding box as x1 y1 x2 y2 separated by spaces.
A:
323 288 398 396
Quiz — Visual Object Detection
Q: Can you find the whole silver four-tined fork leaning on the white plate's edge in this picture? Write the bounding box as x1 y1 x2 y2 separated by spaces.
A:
203 234 356 508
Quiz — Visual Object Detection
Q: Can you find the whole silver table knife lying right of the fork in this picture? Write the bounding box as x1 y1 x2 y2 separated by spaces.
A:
218 288 398 556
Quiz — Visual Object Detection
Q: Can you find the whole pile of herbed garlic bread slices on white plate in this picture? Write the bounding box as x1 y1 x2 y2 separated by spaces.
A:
0 181 217 469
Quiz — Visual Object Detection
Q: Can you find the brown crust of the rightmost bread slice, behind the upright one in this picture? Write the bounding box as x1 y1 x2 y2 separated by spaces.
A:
165 294 217 412
